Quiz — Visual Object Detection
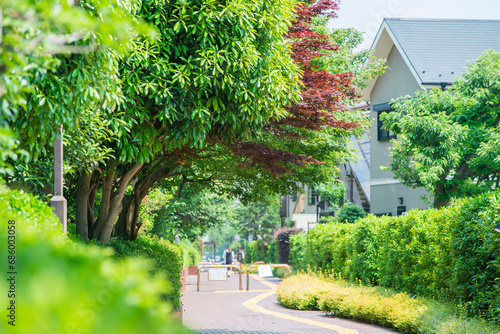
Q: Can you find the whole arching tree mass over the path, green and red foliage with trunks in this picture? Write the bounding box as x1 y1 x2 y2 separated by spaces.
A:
7 0 382 243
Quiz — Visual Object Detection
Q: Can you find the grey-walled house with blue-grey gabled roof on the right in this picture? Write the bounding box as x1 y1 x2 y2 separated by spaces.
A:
363 18 500 215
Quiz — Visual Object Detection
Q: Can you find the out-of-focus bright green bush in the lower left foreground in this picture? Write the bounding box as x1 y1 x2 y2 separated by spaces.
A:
0 186 187 334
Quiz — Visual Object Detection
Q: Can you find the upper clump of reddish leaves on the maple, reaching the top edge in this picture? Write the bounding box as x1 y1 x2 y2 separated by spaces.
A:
277 0 358 131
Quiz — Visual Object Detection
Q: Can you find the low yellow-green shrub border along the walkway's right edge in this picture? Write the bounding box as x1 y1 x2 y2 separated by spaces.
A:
276 274 500 334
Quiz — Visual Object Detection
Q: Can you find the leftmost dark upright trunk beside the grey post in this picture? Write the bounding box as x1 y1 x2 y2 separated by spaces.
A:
75 170 92 240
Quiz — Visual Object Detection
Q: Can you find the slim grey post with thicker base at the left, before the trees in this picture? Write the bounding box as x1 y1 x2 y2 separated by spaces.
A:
50 126 68 233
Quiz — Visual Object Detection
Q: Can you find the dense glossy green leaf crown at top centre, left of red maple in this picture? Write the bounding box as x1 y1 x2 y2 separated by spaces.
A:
118 0 298 154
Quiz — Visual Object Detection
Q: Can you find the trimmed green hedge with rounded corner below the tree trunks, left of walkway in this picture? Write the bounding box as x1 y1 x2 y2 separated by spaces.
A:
108 235 183 308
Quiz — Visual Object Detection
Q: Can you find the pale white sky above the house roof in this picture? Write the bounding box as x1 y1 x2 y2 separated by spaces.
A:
329 0 500 49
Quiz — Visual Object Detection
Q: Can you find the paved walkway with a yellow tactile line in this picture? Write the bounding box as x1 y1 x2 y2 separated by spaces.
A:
182 272 398 334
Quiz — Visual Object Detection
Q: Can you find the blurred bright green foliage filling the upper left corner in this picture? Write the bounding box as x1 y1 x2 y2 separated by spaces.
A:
0 0 153 174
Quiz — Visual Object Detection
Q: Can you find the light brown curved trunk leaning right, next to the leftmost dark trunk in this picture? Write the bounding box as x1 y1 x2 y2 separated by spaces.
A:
96 162 144 244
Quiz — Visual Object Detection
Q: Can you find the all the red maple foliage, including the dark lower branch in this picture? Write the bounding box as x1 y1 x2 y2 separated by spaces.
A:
230 0 360 175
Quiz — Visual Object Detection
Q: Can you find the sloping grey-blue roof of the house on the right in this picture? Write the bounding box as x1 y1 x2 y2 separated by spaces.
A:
384 18 500 84
